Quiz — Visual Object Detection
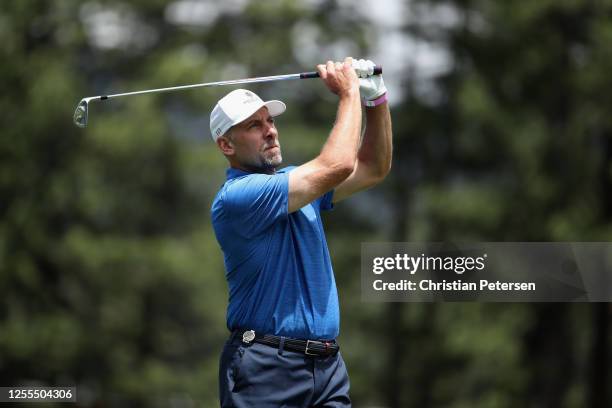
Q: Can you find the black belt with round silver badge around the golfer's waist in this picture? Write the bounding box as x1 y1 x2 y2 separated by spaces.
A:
233 330 340 357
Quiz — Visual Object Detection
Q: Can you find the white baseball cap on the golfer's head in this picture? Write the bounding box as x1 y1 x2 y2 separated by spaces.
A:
210 89 287 142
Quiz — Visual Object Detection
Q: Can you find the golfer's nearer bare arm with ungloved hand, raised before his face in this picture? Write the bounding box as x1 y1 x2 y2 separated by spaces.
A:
289 58 361 213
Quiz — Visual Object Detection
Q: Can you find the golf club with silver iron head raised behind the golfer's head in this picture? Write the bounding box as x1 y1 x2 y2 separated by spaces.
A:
74 65 382 128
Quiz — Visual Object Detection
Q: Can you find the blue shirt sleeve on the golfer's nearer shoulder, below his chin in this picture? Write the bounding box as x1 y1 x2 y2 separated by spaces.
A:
224 173 289 237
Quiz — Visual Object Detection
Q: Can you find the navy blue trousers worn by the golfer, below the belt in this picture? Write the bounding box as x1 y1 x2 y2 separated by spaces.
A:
219 336 351 408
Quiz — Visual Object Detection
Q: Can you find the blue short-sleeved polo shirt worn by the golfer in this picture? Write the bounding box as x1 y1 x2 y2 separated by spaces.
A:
211 166 339 340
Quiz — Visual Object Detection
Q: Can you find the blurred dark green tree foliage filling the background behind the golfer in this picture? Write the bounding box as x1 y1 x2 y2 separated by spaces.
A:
0 0 612 408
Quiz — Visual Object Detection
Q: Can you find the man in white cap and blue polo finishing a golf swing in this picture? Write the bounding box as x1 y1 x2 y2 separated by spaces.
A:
210 58 391 408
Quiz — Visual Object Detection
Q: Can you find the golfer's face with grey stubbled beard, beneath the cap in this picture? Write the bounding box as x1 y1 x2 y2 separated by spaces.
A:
229 106 283 172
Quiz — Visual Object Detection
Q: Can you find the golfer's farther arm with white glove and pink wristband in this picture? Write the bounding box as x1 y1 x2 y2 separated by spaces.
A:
332 61 393 203
